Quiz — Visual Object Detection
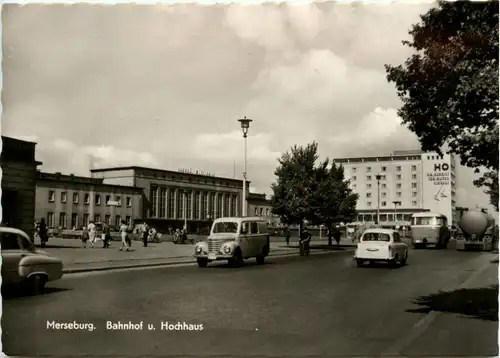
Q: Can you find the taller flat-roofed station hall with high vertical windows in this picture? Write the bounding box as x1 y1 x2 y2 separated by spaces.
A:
91 166 249 232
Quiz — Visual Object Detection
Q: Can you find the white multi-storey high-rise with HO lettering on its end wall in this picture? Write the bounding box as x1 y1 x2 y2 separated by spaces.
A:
334 151 457 225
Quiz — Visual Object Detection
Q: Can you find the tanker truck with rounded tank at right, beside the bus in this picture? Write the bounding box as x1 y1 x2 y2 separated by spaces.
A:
456 210 496 251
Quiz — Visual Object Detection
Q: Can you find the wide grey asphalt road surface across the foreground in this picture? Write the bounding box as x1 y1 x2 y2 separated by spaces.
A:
2 249 498 357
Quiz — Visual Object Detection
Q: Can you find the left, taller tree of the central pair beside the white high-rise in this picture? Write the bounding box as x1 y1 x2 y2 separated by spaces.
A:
271 142 318 232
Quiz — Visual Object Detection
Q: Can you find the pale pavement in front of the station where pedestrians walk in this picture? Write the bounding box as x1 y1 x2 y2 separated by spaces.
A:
42 237 355 274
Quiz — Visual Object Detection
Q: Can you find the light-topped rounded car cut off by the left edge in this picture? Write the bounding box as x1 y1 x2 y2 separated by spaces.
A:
0 227 63 294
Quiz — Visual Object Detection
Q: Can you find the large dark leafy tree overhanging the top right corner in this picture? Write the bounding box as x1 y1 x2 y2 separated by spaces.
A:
385 1 499 211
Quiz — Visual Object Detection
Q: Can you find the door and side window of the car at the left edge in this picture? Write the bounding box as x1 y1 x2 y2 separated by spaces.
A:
0 232 25 284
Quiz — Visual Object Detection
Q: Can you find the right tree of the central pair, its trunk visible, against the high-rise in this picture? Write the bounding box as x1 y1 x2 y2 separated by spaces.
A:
312 159 359 245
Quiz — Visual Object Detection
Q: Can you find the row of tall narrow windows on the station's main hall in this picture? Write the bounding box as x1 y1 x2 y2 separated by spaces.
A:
151 186 238 220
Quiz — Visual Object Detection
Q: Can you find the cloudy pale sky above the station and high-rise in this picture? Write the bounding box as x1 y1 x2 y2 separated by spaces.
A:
1 2 491 214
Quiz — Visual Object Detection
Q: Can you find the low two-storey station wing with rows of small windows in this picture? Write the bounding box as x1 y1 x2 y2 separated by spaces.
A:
35 172 142 229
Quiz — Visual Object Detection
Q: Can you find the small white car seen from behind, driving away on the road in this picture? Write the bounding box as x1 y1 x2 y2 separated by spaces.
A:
354 228 408 267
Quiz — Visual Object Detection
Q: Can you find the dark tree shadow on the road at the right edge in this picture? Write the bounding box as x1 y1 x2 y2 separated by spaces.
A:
407 285 498 321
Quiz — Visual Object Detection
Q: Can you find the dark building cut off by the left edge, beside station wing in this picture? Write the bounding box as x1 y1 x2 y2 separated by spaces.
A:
0 136 42 237
